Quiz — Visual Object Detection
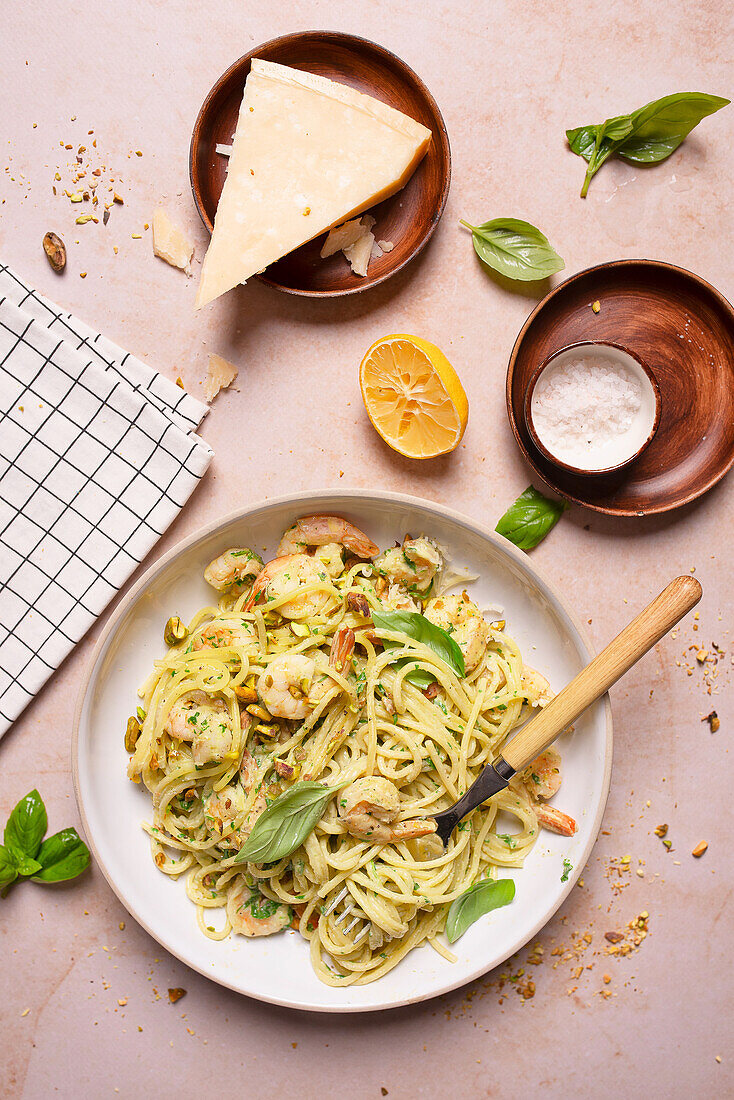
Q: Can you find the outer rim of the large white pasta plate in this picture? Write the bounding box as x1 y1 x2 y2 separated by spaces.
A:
70 486 614 1014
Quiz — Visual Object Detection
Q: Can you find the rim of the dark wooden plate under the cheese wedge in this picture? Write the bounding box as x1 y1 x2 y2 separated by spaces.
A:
188 30 451 298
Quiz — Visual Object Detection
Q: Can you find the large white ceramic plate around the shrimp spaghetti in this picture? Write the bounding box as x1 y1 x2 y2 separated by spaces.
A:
72 491 612 1012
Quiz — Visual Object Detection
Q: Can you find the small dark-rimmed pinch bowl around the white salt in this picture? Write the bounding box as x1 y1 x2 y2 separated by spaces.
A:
523 340 661 477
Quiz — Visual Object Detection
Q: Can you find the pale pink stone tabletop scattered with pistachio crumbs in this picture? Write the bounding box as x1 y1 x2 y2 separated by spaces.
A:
0 0 734 1100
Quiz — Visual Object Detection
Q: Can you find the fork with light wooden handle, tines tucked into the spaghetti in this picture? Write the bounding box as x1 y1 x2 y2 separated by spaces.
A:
322 576 703 944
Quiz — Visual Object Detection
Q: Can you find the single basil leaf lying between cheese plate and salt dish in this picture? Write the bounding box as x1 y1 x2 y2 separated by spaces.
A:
461 218 566 283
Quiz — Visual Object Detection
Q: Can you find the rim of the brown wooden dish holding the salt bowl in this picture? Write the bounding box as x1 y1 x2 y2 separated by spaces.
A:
505 256 734 518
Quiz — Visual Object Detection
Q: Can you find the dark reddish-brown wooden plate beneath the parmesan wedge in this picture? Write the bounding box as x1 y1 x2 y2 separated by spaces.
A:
189 31 451 297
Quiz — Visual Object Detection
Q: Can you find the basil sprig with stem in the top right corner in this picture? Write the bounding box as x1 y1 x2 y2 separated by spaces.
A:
566 91 730 198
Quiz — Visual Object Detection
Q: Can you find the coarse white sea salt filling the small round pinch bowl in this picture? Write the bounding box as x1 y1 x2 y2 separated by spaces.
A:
530 349 655 471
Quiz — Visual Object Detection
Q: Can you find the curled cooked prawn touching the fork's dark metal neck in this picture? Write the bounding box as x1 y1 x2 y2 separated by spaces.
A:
339 776 436 844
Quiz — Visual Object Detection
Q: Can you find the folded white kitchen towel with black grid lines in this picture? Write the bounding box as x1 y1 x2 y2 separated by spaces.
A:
0 263 212 737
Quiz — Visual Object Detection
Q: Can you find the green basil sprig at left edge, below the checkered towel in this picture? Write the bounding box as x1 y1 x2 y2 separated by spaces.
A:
0 789 89 889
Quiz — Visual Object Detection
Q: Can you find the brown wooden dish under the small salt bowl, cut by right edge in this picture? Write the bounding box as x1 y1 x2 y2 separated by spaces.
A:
506 260 734 516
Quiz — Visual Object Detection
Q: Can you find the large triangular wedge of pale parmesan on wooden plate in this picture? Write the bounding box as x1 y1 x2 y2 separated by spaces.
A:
196 58 431 307
